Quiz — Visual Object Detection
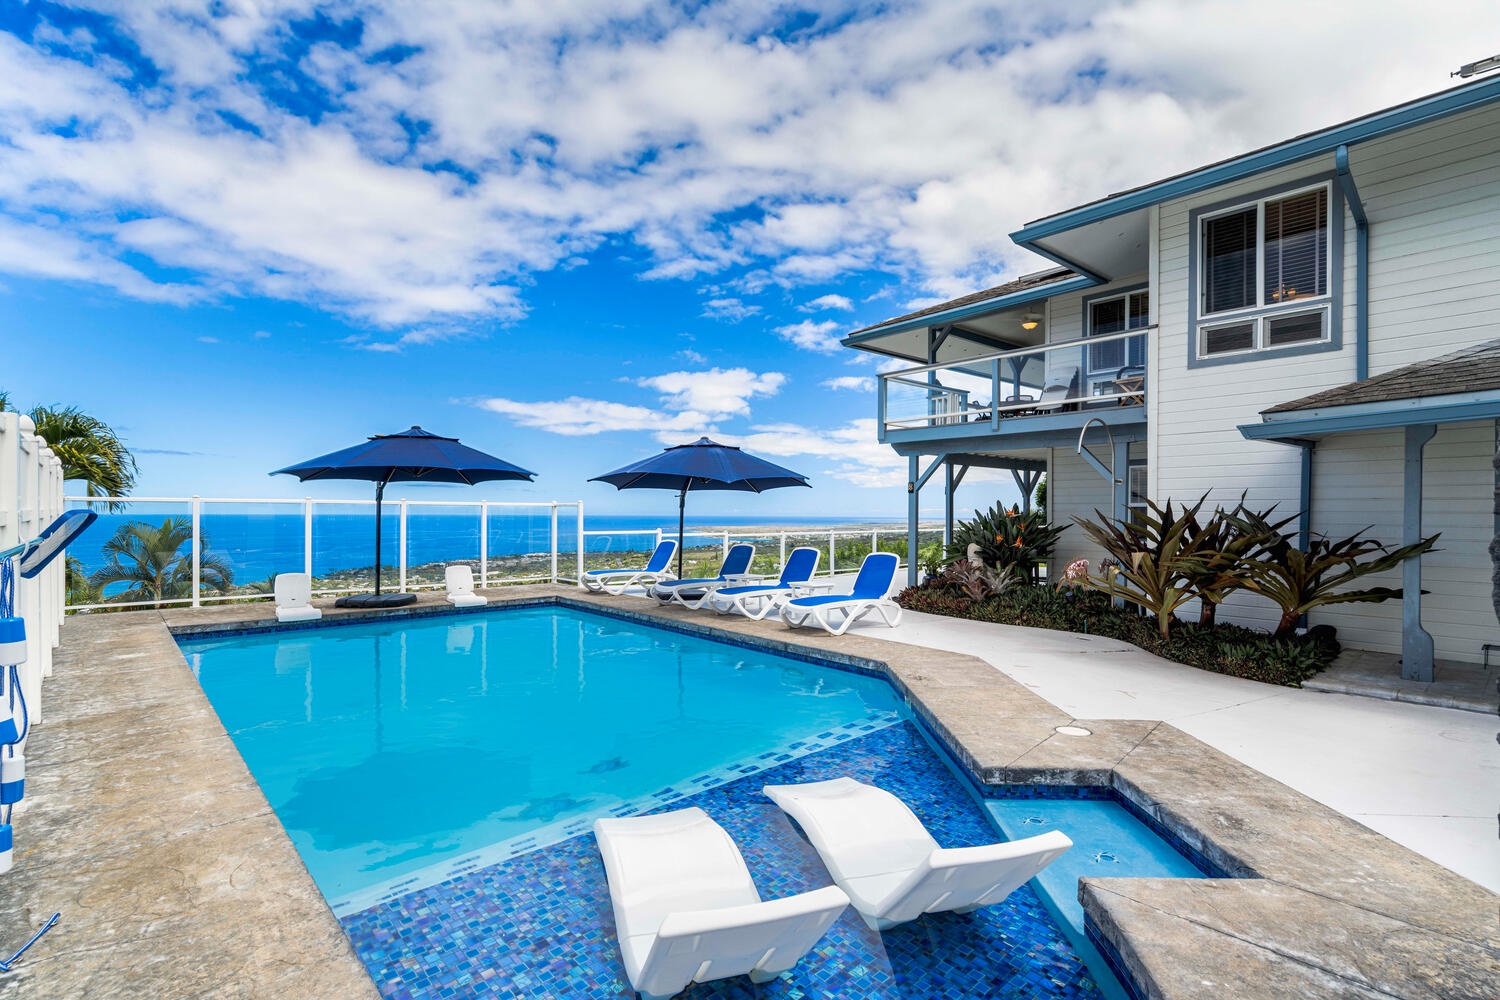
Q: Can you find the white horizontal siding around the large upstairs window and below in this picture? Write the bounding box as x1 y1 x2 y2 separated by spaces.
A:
1151 106 1500 650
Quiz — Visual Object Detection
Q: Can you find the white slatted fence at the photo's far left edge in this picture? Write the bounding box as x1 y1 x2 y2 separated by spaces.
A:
0 412 66 723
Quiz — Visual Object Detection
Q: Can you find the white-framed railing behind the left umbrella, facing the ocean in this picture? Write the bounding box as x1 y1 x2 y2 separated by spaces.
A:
66 496 585 610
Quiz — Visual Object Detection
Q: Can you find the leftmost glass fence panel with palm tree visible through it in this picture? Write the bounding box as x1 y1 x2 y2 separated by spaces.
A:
68 501 192 607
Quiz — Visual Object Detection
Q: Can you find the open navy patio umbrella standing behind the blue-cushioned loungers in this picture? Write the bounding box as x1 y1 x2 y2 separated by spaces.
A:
590 438 810 577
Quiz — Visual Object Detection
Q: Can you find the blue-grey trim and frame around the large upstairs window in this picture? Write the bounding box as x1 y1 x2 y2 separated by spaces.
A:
1188 172 1344 369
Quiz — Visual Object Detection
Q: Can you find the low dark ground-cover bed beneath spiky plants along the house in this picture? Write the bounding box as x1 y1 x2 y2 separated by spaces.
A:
896 582 1338 687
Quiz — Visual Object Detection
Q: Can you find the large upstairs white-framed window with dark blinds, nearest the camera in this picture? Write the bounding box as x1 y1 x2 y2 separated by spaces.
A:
1197 184 1332 357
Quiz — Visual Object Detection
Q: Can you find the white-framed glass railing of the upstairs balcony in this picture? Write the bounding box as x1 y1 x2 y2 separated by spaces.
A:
881 327 1155 430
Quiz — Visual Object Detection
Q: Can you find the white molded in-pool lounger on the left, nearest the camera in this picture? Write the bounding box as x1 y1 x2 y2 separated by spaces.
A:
594 808 849 1000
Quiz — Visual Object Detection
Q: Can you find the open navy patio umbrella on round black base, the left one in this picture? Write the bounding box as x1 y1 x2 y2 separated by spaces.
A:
272 426 536 607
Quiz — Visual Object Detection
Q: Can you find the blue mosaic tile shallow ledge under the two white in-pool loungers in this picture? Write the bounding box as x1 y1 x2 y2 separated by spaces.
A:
342 723 1100 1000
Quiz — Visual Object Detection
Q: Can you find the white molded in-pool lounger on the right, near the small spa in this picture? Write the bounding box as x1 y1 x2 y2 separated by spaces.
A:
765 778 1073 931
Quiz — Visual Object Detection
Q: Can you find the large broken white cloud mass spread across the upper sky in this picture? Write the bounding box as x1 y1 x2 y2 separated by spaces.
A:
0 0 1494 328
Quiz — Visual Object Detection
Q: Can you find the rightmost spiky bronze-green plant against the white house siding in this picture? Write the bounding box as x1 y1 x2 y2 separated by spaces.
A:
1236 508 1439 637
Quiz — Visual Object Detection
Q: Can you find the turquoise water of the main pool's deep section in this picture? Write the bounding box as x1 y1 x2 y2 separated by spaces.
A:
182 607 900 913
